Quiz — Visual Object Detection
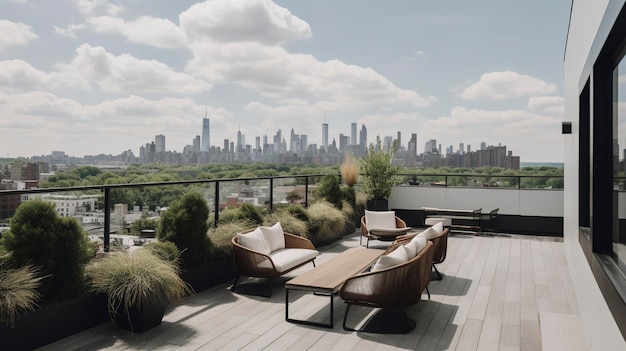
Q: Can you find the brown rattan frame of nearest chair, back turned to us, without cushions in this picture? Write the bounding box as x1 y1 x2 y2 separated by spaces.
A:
339 242 433 333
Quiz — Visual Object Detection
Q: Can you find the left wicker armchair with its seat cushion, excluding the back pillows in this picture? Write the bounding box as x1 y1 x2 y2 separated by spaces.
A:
231 229 319 296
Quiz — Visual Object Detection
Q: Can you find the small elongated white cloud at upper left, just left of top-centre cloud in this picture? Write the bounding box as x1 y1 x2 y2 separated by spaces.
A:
87 16 187 49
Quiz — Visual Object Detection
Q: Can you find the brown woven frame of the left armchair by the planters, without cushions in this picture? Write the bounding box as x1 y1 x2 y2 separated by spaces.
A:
231 229 315 296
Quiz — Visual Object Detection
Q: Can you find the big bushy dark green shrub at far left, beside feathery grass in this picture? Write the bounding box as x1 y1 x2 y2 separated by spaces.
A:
2 200 94 305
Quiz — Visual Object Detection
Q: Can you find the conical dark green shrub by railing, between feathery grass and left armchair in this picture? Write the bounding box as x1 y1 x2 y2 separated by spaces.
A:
157 192 211 268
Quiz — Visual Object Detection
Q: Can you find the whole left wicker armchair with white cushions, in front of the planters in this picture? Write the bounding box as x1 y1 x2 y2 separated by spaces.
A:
231 223 319 296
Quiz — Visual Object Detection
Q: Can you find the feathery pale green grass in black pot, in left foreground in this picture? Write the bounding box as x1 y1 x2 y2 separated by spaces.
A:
85 248 192 333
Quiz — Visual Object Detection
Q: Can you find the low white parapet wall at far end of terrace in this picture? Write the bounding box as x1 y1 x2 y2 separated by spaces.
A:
389 185 563 217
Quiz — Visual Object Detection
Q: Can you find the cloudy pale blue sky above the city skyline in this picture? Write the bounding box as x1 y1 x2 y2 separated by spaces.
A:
0 0 571 162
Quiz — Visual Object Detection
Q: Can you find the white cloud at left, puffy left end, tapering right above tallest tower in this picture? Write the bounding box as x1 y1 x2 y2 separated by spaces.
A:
56 44 211 94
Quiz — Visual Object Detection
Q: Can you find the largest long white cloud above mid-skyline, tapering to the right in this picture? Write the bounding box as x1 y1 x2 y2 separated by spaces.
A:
187 42 432 110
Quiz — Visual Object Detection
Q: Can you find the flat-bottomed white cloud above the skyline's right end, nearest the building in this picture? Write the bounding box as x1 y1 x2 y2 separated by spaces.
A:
461 71 556 100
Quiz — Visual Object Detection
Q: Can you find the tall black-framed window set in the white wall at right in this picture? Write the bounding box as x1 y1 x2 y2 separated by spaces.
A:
579 4 626 338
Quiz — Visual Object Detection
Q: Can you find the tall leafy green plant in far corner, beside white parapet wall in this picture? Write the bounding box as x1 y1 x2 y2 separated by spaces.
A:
361 137 402 210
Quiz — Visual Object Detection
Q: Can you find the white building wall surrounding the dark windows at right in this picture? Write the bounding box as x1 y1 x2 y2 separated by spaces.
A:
563 0 626 350
